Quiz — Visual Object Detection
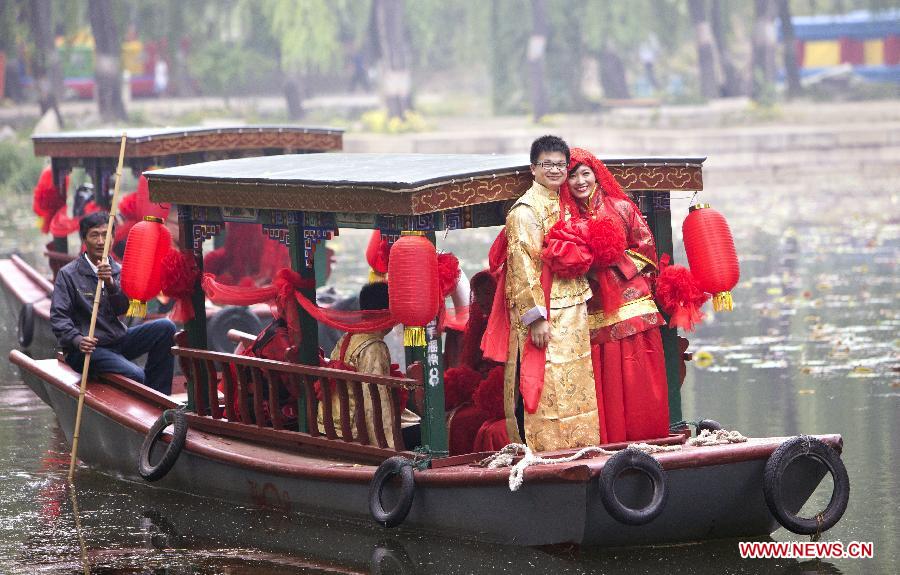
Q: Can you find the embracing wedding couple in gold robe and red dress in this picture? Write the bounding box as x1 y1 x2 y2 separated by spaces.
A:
483 136 669 451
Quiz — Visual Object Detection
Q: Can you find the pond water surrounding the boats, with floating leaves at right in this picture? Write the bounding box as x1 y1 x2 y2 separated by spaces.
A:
0 164 900 575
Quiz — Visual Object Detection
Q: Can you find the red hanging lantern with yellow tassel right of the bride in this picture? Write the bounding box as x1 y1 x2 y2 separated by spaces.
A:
681 204 741 311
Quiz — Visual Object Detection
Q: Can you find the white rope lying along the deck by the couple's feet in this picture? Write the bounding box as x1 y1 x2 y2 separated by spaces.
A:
478 429 747 491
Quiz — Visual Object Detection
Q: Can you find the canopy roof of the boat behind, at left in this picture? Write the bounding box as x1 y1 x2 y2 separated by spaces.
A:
32 125 343 161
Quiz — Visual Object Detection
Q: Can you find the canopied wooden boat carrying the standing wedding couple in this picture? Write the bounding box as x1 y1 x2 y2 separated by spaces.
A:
10 154 849 546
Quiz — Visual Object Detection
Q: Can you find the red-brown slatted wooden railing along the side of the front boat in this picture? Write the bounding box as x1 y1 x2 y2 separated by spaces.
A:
172 346 423 456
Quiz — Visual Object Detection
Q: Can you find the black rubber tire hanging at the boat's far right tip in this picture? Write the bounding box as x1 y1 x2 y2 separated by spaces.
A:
763 435 850 535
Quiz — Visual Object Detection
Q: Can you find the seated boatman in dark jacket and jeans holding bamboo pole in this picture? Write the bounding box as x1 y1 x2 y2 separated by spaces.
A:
50 212 175 394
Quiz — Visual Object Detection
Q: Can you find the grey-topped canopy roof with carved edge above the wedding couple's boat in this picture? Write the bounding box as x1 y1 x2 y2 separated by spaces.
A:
144 153 705 216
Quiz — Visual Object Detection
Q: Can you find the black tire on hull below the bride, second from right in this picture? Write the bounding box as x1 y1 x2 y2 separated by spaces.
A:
599 449 669 525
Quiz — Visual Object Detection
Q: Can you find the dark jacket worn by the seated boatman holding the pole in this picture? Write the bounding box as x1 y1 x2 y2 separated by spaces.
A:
50 254 128 353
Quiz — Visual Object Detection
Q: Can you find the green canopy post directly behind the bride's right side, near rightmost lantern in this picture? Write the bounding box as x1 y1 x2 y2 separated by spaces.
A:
642 191 684 423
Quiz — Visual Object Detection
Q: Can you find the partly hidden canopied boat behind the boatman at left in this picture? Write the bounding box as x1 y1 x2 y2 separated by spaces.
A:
0 125 343 357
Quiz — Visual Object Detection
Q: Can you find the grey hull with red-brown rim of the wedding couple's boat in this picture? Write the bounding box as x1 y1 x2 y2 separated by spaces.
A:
10 351 841 546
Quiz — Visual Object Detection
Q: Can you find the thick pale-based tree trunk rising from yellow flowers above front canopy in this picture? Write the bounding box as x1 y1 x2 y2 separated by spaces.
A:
373 0 412 118
